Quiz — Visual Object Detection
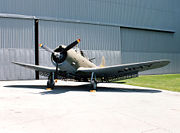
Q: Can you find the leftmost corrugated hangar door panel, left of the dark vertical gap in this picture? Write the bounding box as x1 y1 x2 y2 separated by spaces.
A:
0 18 35 80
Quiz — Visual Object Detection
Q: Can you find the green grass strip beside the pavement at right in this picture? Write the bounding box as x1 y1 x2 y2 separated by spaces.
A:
116 74 180 92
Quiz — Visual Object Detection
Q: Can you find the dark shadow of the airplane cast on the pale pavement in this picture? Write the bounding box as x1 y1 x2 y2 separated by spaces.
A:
4 84 161 95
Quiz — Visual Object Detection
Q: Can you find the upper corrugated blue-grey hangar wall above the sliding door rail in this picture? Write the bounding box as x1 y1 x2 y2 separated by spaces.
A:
0 0 176 29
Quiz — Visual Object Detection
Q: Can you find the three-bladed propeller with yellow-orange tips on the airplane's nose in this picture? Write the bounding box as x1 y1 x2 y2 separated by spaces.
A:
39 39 80 78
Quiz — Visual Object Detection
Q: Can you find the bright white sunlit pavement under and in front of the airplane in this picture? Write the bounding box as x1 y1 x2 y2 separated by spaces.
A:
0 80 180 133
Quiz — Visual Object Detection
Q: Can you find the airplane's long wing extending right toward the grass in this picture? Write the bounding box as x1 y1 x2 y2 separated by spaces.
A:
77 60 170 78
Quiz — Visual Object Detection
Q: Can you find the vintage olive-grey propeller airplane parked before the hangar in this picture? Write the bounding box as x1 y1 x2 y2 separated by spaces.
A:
12 39 170 90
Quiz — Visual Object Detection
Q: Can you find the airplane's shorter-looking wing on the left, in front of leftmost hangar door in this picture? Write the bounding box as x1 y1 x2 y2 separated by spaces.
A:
12 62 56 75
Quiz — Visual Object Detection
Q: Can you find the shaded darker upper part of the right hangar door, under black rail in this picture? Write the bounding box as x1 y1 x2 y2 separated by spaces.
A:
121 28 176 53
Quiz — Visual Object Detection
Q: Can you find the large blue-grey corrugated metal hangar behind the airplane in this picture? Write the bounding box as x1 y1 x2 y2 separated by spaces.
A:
0 0 180 80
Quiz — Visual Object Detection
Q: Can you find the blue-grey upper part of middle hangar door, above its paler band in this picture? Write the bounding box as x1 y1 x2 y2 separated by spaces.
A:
39 20 121 51
